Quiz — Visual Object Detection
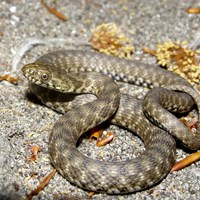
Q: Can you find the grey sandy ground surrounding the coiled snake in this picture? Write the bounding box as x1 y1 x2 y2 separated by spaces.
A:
0 0 200 200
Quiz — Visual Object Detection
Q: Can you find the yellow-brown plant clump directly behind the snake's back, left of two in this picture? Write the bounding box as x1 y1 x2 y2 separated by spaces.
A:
89 23 135 59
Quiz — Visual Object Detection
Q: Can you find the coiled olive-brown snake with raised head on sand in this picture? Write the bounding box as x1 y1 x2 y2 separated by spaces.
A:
22 50 200 194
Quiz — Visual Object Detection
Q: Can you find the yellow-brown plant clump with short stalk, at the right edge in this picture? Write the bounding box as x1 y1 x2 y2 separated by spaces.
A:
143 41 200 84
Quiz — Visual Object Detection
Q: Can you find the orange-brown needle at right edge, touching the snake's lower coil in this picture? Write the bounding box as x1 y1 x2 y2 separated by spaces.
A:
171 152 200 172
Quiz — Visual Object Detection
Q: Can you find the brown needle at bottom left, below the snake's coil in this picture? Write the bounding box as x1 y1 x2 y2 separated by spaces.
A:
28 169 56 200
